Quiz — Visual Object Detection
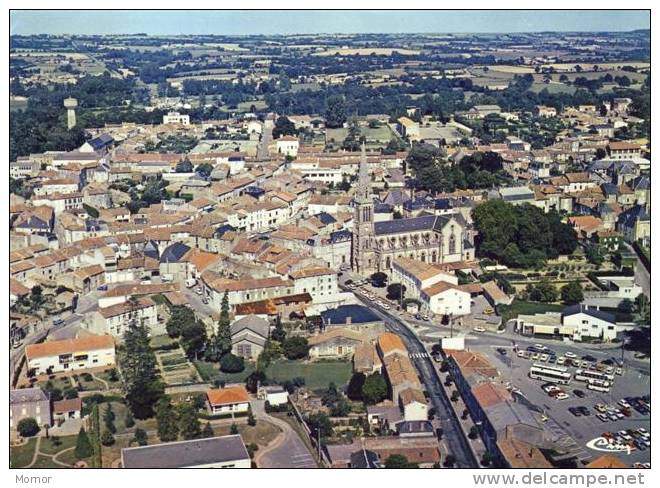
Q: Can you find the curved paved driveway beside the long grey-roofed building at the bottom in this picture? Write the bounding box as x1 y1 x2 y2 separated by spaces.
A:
250 400 318 469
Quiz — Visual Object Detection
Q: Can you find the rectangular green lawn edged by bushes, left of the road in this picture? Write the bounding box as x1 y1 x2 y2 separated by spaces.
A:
266 361 352 390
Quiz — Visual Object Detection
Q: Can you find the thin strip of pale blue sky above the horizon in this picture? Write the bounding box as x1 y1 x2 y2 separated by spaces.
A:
10 10 651 35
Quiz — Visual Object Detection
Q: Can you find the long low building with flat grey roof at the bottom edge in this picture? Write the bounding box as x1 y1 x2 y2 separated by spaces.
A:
121 434 251 469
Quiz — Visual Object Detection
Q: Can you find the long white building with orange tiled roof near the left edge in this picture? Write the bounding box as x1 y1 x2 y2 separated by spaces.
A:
25 336 115 375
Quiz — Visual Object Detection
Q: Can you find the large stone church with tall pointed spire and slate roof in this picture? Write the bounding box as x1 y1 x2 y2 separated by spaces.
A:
351 145 474 276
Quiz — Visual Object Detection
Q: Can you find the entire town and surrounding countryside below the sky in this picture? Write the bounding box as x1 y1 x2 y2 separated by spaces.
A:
9 20 651 469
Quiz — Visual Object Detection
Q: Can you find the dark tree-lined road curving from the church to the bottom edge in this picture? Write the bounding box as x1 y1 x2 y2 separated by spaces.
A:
347 284 479 468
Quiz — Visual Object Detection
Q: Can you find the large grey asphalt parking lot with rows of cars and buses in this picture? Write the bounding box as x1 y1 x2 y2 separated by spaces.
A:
471 344 651 465
